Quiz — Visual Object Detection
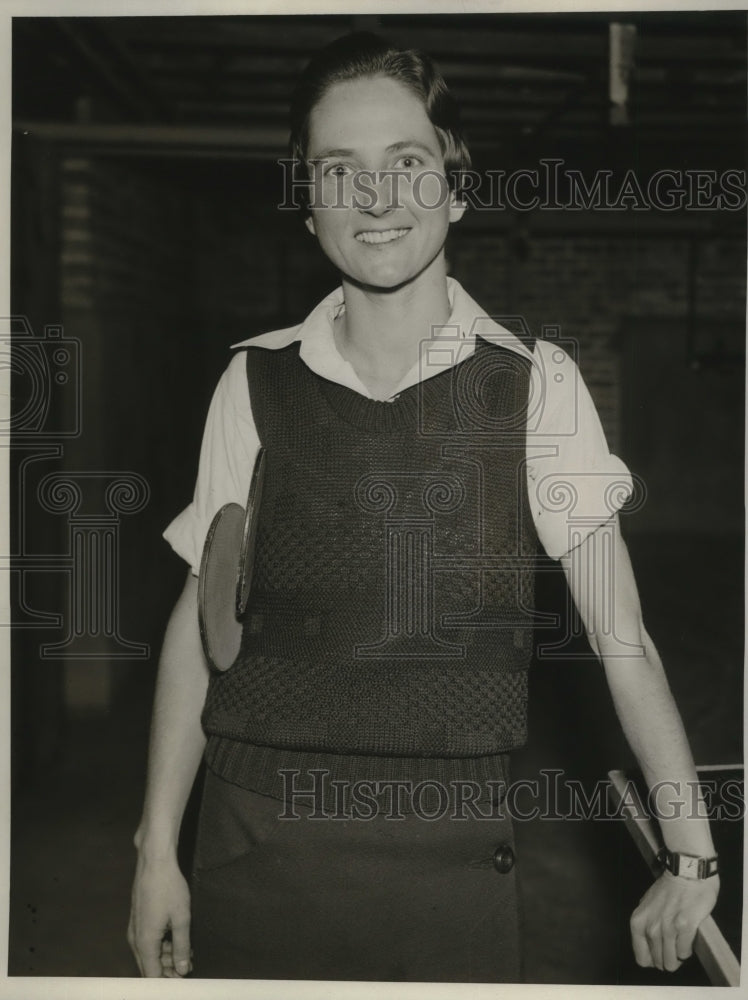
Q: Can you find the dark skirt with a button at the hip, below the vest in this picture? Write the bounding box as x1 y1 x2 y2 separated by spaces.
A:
191 769 522 983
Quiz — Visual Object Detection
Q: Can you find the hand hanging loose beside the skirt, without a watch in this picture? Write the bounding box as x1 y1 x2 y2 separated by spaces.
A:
127 856 192 979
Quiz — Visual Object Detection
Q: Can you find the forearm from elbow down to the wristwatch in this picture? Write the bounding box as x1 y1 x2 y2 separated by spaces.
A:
601 626 715 856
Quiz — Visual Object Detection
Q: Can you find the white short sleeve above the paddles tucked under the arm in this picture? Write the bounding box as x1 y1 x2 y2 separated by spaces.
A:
163 351 260 576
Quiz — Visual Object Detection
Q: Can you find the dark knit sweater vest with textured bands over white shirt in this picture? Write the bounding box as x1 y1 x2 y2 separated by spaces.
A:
202 338 537 790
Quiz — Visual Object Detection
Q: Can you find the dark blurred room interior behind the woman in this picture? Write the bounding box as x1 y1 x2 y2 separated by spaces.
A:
9 11 746 984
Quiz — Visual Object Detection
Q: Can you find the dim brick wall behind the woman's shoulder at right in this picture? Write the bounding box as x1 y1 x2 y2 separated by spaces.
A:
450 234 745 450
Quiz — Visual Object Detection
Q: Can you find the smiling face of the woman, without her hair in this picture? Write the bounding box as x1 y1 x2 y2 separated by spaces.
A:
306 76 464 289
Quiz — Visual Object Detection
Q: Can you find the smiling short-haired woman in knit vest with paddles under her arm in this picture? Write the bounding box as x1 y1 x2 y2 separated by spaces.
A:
129 34 719 982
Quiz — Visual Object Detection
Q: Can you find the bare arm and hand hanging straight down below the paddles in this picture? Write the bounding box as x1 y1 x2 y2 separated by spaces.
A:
128 573 209 976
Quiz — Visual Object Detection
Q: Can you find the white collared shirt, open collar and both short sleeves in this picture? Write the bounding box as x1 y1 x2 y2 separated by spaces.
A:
164 277 632 575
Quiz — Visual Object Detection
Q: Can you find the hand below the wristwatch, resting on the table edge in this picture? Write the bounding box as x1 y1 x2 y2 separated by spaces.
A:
631 871 719 972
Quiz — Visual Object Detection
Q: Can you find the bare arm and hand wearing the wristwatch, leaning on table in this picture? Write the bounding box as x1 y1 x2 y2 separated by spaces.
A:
561 518 719 971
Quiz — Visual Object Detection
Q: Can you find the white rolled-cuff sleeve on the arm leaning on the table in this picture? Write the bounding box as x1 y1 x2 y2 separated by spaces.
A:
527 340 633 559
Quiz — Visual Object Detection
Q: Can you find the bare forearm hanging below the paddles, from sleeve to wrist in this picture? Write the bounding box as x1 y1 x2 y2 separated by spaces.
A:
135 577 209 858
